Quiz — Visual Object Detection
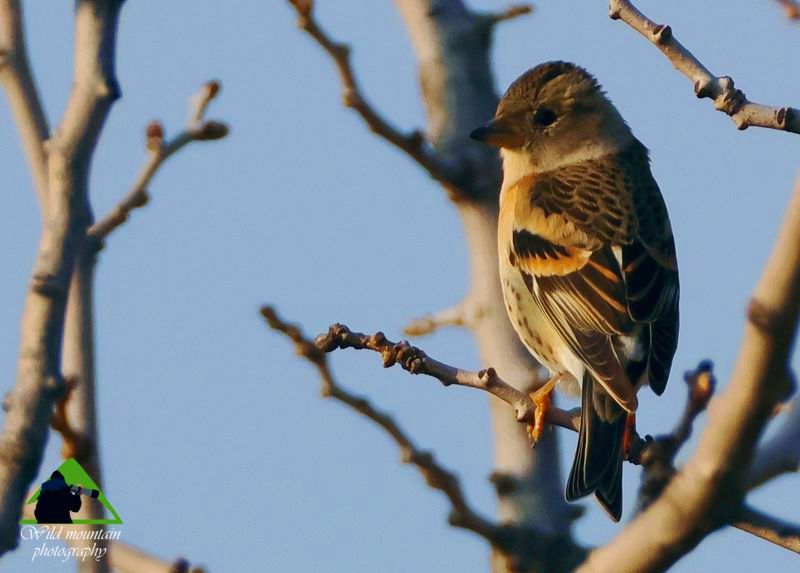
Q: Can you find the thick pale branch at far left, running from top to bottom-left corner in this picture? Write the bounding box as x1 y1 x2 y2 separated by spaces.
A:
0 0 122 554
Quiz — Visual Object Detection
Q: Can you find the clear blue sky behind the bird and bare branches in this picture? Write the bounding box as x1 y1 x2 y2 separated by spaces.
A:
0 0 800 573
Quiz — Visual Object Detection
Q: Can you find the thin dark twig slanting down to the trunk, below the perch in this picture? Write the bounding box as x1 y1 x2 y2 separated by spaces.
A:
261 306 499 544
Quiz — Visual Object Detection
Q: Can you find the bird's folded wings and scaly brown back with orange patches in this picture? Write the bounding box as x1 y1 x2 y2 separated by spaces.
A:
509 140 677 411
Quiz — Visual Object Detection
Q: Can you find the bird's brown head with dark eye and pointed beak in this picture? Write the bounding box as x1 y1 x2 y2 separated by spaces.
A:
470 62 632 171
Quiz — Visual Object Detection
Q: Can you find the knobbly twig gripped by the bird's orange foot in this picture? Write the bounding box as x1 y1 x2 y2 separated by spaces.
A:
314 324 580 431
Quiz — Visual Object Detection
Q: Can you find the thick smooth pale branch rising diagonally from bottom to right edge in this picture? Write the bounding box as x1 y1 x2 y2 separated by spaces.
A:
579 177 800 573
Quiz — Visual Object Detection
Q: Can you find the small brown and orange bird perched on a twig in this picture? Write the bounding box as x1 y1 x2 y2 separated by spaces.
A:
470 61 680 521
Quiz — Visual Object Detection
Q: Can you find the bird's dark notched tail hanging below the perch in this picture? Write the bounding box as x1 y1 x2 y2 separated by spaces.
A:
566 372 626 521
